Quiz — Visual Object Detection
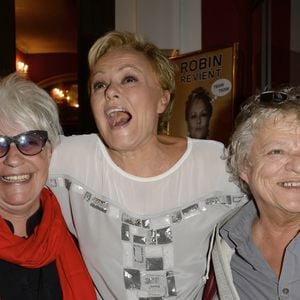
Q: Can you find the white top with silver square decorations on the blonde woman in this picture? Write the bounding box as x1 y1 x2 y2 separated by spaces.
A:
48 134 244 300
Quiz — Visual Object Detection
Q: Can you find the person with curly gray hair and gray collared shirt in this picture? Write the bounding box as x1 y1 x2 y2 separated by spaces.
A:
209 88 300 300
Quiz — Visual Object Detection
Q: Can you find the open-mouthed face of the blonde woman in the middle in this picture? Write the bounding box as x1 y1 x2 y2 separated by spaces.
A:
90 49 170 151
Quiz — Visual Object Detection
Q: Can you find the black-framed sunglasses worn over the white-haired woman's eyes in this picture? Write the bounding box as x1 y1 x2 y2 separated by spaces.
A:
0 130 48 157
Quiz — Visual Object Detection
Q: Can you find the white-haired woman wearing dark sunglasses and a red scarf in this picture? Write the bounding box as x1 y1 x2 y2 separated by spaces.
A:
0 73 96 300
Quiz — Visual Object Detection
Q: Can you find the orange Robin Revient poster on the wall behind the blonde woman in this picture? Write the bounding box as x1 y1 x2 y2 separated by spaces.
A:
168 44 238 144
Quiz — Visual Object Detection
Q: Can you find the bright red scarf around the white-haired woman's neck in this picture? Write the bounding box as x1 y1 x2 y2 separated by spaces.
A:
0 188 96 300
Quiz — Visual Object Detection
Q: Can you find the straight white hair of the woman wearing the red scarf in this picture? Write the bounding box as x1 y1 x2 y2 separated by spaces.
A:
0 73 62 147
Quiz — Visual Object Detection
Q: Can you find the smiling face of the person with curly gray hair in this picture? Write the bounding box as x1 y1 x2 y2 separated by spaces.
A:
241 114 300 216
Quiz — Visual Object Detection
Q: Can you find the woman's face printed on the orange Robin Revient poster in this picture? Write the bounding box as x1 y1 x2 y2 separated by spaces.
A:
186 98 210 139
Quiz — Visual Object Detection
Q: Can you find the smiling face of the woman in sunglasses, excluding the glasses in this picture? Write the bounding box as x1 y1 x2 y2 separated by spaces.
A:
0 130 52 220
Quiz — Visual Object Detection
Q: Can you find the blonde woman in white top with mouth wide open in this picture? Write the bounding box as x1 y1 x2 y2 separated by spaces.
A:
50 32 246 300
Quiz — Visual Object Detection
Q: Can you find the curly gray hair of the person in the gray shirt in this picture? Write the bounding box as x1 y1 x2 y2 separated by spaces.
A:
225 87 300 194
